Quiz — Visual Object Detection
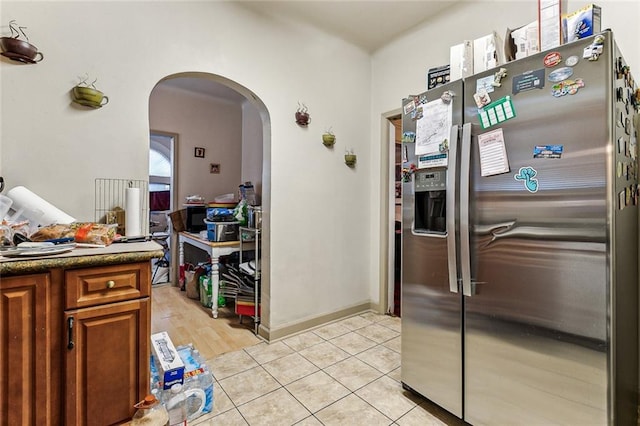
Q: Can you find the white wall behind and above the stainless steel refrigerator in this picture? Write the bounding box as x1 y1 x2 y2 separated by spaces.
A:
369 0 640 300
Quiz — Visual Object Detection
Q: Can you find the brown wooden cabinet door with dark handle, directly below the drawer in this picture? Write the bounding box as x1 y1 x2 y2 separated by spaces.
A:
65 297 151 425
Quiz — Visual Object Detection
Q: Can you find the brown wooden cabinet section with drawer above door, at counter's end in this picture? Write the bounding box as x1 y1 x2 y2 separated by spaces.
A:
64 262 151 425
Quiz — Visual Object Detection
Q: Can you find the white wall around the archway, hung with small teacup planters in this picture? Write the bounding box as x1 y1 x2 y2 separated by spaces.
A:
0 1 376 330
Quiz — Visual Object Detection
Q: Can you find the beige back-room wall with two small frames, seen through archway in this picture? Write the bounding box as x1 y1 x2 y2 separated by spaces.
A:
149 84 244 203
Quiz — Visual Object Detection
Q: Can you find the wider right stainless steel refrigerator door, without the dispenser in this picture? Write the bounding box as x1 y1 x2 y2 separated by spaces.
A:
464 35 613 425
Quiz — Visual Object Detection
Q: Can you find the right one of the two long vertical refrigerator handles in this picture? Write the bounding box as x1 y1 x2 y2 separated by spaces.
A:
460 123 473 296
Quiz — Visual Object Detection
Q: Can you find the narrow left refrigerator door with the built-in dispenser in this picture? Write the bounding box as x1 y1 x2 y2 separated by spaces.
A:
401 81 463 417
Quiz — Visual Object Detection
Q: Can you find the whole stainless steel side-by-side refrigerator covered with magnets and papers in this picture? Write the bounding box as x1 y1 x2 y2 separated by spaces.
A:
402 31 639 425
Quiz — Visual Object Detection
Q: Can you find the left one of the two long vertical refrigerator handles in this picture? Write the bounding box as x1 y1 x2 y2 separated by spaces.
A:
446 125 459 293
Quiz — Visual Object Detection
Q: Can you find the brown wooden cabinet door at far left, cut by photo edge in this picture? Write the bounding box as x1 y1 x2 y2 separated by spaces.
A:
0 274 52 425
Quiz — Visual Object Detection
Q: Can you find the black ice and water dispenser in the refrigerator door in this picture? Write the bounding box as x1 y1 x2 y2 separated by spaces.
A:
413 169 447 234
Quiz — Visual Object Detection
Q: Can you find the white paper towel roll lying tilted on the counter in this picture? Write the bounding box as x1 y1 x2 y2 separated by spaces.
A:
7 186 76 226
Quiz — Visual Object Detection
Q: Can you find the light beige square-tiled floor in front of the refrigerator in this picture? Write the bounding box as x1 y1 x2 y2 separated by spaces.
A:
190 313 463 426
